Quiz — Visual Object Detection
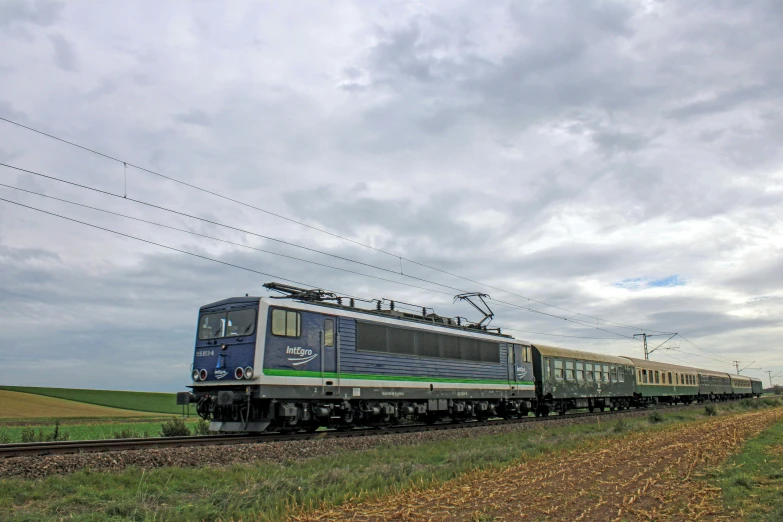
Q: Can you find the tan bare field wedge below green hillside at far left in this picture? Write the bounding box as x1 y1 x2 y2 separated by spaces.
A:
0 390 158 419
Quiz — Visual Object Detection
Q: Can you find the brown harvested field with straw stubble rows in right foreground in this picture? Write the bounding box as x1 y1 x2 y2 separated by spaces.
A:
294 408 783 522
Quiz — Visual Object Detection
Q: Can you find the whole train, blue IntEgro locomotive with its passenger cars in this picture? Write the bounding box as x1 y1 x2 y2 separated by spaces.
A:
177 283 763 433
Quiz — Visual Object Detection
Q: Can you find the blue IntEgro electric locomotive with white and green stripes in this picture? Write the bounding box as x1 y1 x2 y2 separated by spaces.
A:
178 283 535 432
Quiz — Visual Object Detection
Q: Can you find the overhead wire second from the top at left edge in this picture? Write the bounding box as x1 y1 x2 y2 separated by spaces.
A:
0 163 644 339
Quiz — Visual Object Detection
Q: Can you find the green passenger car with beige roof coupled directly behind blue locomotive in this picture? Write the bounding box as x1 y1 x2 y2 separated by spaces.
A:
532 344 634 415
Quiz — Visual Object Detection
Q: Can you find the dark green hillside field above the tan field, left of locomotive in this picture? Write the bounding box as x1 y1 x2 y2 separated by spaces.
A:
0 386 188 414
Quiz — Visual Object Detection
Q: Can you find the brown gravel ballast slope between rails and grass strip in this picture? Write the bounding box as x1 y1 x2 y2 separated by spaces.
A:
0 410 676 479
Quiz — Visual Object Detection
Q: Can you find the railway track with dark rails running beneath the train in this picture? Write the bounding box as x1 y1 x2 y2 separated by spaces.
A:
0 401 735 458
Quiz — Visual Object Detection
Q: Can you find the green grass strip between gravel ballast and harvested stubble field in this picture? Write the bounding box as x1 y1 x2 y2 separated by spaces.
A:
0 400 780 520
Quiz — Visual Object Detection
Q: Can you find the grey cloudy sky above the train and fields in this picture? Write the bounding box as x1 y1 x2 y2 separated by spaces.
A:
0 0 783 391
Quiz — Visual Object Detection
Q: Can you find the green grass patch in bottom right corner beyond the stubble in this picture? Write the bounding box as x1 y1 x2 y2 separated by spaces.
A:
711 410 783 522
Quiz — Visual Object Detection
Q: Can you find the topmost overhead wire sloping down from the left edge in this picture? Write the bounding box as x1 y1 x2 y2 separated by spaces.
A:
0 116 671 333
